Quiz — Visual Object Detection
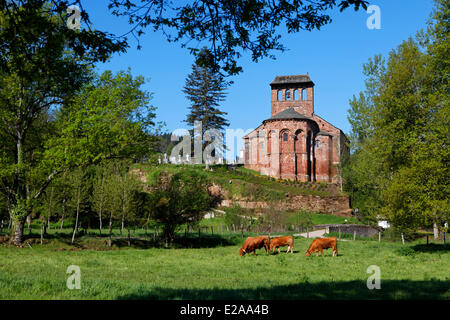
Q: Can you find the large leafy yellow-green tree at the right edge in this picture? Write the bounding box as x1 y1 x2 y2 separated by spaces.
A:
346 0 450 236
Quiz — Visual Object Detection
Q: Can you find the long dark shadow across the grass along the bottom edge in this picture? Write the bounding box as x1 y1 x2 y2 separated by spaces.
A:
118 280 450 300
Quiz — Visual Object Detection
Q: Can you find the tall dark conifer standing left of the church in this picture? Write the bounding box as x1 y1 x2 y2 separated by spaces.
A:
183 48 230 166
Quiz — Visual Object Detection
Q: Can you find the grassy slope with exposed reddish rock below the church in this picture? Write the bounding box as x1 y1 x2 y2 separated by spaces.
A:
132 164 352 216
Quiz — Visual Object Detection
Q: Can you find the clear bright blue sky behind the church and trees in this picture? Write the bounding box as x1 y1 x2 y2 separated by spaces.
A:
83 0 433 159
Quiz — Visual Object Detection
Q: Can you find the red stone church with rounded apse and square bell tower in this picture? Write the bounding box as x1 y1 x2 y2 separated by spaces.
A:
244 75 349 183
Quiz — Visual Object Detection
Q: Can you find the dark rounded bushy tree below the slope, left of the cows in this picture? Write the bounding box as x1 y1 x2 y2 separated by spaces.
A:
150 169 213 247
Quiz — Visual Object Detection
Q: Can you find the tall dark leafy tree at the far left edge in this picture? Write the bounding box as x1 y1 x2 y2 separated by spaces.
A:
0 1 124 244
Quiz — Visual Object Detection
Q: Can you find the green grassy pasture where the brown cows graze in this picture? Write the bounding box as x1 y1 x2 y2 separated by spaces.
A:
0 232 450 299
